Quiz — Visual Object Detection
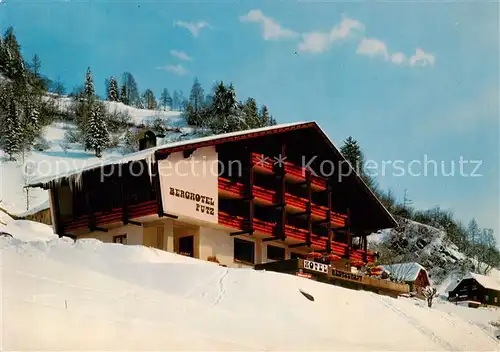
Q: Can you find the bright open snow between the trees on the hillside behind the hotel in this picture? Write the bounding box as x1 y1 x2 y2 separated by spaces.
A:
0 95 196 216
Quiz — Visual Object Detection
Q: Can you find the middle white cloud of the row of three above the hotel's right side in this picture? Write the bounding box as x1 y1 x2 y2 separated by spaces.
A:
298 18 364 54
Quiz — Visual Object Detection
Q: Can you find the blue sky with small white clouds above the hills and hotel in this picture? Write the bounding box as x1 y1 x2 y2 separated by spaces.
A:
0 0 500 241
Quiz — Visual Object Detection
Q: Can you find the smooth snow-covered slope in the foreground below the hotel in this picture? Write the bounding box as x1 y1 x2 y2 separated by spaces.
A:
0 216 500 351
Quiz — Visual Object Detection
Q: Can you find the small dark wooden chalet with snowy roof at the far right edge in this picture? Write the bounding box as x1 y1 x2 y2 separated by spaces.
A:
448 273 500 307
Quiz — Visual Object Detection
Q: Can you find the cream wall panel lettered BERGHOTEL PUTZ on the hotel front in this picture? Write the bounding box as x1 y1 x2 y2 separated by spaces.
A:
158 146 219 224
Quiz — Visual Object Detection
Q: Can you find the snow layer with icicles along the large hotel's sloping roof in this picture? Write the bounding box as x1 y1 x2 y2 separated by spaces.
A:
28 122 311 186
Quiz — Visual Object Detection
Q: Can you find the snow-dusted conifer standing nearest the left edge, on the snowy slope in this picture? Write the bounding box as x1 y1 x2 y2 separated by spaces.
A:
1 97 23 160
